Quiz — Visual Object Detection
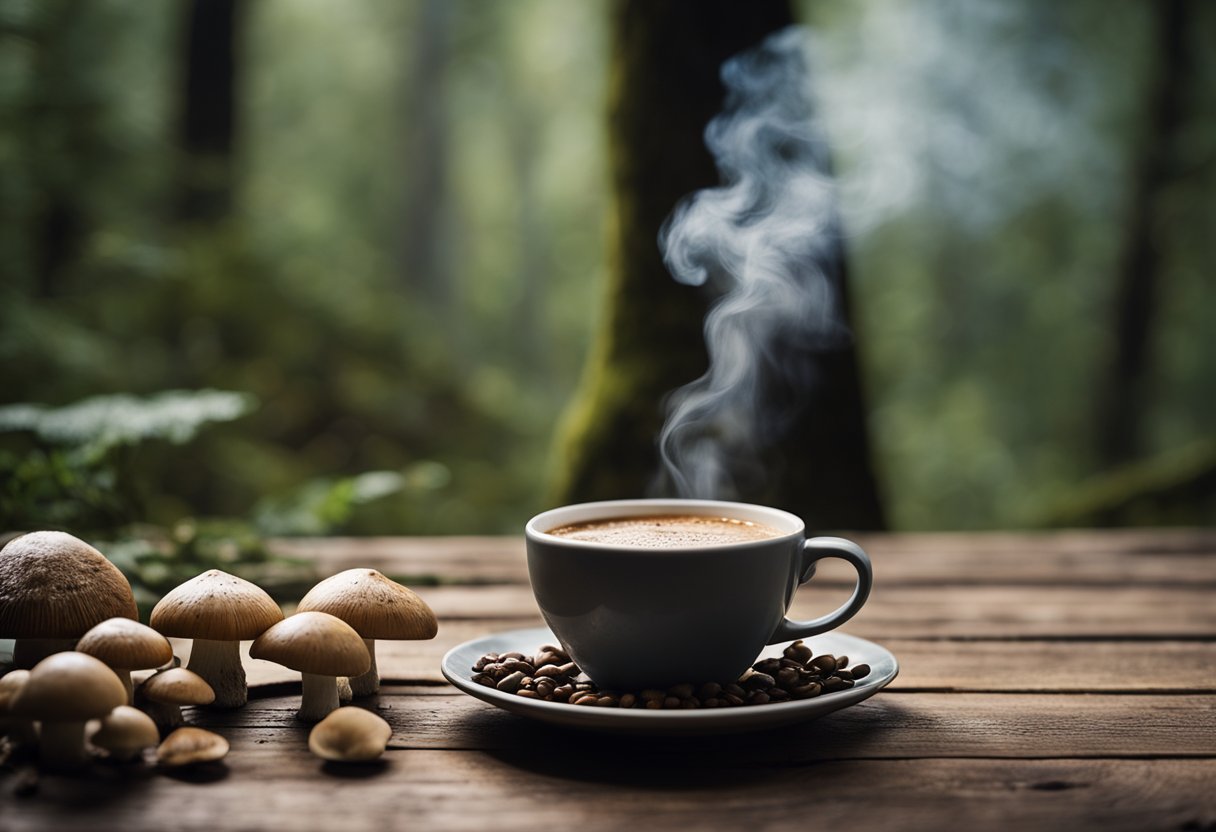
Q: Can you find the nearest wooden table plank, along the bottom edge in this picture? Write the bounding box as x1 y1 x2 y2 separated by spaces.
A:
0 737 1216 832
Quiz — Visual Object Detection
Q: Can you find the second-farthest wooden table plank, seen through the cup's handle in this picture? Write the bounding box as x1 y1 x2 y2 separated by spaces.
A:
393 584 1216 639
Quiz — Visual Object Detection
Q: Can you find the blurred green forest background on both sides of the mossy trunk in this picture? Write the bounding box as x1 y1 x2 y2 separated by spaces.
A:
0 0 1216 559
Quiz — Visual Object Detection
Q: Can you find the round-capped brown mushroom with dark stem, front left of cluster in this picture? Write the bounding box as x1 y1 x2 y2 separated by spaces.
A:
11 652 126 769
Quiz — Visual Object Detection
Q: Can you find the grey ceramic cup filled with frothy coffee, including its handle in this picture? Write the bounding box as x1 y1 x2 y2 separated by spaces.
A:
525 500 872 690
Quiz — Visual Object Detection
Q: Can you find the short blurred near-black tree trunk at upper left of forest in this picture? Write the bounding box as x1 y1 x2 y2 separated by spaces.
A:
178 0 244 221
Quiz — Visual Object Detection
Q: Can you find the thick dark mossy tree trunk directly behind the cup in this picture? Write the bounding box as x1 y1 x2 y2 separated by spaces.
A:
551 0 883 528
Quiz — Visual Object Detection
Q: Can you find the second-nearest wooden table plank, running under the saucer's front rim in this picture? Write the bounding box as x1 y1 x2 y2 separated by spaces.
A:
182 686 1216 764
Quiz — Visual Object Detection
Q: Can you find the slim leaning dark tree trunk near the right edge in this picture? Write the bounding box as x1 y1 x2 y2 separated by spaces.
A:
1094 0 1188 467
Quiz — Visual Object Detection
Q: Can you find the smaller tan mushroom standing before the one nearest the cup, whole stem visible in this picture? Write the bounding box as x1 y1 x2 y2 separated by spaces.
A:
249 612 371 723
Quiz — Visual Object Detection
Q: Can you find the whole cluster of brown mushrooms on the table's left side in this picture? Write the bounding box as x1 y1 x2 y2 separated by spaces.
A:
0 532 438 770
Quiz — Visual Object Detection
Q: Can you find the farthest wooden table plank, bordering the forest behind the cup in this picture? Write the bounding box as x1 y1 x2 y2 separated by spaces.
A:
274 529 1216 586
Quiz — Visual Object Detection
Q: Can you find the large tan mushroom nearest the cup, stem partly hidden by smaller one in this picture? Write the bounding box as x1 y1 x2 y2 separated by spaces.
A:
298 569 439 696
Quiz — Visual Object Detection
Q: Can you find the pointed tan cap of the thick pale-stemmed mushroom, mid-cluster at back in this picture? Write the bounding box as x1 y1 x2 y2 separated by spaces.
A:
148 569 283 641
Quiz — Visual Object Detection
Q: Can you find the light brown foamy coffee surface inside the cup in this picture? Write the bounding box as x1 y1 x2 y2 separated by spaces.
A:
547 515 782 549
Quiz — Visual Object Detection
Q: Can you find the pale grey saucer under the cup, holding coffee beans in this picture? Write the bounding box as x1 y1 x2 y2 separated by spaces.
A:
443 626 900 735
